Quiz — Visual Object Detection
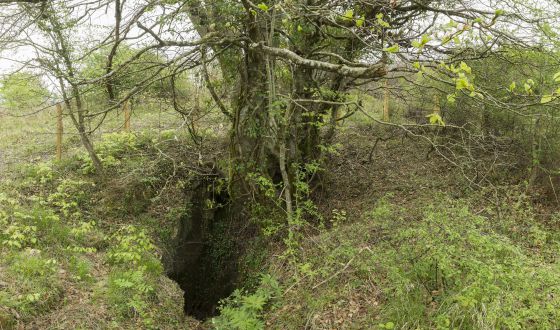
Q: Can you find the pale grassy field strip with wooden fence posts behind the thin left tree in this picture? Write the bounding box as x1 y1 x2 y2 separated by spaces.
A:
0 103 188 173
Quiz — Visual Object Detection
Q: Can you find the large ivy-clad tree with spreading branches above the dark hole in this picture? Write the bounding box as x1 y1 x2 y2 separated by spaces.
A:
154 0 560 209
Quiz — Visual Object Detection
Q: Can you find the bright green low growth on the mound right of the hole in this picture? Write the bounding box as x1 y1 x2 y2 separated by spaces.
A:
268 197 560 329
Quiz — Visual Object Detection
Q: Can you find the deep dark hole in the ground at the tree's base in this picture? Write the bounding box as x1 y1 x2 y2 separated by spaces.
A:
168 182 238 321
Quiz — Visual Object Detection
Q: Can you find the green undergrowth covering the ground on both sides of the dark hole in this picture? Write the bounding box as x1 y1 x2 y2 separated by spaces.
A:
0 127 560 330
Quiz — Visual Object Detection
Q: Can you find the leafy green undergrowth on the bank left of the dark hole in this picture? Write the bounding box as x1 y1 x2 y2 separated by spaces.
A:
0 133 189 329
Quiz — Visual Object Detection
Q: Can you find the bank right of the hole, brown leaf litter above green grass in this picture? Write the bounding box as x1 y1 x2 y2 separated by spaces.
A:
248 130 560 329
